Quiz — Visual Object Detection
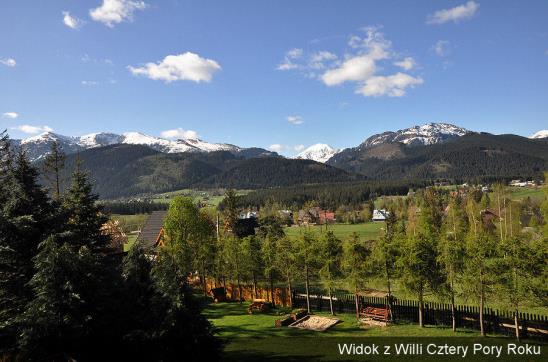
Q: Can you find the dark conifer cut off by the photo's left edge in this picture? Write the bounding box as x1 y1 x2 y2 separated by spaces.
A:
0 150 53 344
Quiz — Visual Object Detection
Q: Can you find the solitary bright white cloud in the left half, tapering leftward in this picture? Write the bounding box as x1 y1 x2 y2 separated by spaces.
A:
127 52 221 83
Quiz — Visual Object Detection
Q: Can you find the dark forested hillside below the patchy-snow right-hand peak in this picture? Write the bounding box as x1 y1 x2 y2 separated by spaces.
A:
328 133 548 181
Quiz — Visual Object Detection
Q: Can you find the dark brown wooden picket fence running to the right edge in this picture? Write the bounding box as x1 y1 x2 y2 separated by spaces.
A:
293 291 548 340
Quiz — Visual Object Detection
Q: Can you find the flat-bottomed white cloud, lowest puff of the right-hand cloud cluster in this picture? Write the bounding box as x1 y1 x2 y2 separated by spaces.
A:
356 72 423 97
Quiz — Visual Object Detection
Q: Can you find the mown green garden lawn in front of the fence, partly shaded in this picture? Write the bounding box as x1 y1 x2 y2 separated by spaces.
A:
204 303 534 361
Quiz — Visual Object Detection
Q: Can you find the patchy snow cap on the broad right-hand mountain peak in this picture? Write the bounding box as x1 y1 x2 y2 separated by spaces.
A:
360 123 470 147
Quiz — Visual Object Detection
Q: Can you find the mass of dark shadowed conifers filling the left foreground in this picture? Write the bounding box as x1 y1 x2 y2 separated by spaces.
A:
0 133 220 361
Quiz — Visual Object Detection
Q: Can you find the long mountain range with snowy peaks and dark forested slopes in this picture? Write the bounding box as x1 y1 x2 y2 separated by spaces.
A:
8 123 548 199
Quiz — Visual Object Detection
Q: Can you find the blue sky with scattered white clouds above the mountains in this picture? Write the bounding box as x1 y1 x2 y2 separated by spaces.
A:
0 0 548 155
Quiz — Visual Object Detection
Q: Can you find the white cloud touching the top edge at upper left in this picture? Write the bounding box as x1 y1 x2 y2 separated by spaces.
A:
89 0 148 28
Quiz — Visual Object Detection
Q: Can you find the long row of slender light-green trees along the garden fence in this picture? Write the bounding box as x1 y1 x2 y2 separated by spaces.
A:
208 185 548 338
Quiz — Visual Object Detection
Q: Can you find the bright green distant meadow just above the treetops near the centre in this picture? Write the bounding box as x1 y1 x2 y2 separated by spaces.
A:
284 222 384 240
